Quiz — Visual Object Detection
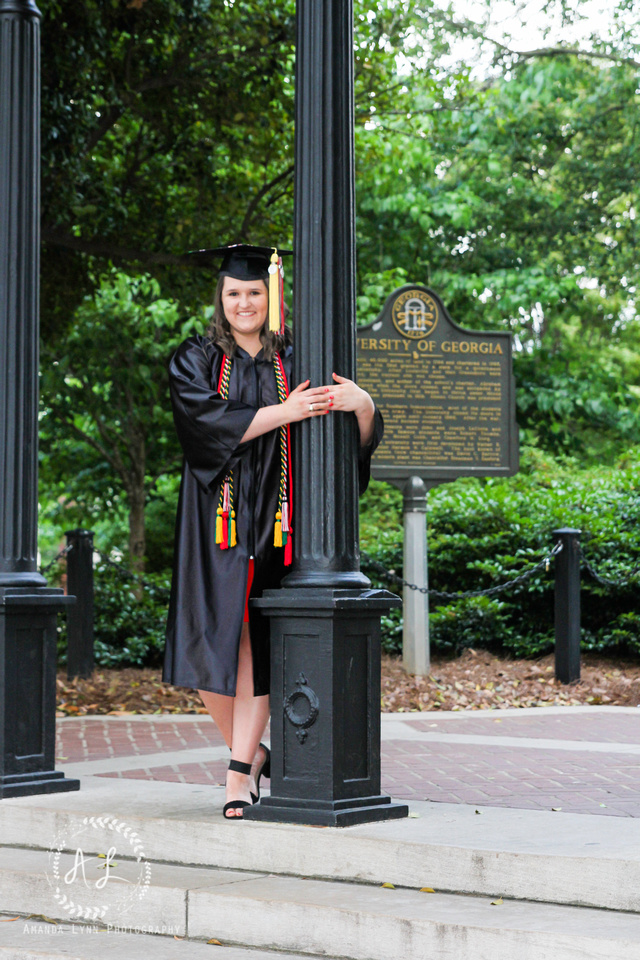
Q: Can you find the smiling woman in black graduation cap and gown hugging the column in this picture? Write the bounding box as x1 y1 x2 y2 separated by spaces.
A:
162 244 383 819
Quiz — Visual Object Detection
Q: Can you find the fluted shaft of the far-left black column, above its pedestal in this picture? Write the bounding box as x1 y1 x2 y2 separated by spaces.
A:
0 0 45 585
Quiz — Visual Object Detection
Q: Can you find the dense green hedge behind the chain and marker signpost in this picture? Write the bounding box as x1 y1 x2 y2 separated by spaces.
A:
361 447 640 656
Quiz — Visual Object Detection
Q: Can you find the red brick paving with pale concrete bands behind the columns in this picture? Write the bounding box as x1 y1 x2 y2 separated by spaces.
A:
56 707 640 818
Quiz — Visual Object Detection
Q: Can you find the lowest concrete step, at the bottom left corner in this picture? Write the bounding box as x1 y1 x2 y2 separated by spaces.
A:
0 914 320 960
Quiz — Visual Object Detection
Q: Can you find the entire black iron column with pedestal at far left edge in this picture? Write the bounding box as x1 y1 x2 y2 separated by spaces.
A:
0 0 80 797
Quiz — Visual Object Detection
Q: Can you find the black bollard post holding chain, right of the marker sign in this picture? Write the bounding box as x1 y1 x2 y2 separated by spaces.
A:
553 527 581 683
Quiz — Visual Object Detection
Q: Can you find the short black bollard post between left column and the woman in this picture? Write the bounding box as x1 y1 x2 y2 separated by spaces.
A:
65 530 94 680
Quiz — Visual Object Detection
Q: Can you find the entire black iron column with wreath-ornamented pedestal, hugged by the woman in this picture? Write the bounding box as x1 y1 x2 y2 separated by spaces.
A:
244 0 408 826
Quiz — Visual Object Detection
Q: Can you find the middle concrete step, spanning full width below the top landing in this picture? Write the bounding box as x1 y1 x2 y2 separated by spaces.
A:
0 848 640 960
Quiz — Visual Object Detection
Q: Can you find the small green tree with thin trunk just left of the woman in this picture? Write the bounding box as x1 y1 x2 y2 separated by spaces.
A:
41 272 197 570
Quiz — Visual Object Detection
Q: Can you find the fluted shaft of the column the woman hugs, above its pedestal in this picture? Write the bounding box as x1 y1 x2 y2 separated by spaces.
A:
284 0 369 587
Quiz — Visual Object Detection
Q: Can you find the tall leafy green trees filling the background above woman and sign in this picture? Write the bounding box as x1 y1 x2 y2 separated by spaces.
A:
42 0 640 588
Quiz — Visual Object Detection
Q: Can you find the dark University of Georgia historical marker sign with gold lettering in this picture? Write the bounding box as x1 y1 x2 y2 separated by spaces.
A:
357 284 518 485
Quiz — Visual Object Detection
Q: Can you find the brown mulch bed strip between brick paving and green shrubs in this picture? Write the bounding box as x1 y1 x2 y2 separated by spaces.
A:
57 650 640 716
